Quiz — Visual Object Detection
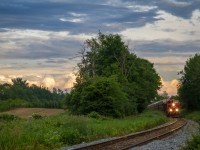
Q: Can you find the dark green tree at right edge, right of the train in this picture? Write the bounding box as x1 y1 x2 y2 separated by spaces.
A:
178 54 200 110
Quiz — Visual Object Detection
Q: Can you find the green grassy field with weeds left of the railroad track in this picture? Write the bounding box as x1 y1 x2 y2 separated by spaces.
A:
0 111 167 150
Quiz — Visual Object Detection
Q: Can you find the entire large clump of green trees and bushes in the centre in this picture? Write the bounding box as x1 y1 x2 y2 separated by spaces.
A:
65 32 161 117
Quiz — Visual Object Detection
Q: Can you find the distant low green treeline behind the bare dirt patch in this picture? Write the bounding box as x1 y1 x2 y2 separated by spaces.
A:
0 78 65 110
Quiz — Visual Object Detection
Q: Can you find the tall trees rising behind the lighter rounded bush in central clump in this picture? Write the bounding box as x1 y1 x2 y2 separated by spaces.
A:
67 32 161 116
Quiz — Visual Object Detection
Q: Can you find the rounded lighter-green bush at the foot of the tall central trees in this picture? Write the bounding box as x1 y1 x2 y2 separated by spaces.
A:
65 77 128 117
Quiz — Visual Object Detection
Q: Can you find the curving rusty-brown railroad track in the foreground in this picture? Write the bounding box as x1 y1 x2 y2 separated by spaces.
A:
66 119 187 150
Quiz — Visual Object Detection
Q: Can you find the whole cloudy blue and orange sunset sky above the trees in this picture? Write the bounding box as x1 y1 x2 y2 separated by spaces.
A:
0 0 200 95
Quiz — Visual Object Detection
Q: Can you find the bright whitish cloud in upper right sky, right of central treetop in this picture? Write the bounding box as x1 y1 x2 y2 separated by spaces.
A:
120 10 200 42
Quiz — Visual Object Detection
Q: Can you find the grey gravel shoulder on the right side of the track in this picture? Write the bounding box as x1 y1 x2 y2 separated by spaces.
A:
130 120 199 150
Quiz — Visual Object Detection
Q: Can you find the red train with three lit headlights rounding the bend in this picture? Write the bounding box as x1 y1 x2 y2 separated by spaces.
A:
148 99 181 117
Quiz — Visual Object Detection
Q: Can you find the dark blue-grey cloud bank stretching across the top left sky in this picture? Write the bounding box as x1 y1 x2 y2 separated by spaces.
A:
0 0 157 34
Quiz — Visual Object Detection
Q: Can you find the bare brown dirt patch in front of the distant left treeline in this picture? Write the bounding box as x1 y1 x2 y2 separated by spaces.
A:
0 108 64 118
